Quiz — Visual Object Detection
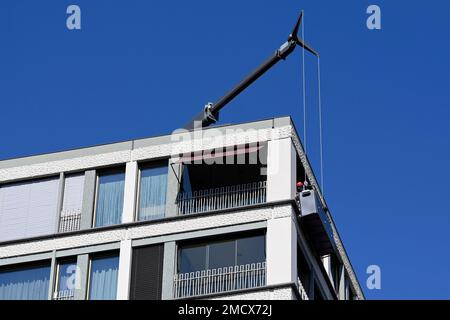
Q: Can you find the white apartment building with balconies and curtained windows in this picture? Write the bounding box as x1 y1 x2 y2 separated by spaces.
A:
0 117 364 300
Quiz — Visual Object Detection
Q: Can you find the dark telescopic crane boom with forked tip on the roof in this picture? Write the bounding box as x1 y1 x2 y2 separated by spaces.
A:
185 11 319 130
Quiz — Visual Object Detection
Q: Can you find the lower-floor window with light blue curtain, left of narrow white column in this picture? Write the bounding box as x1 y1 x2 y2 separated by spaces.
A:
89 255 119 300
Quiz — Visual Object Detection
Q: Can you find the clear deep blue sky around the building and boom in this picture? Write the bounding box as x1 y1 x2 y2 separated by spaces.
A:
0 0 450 299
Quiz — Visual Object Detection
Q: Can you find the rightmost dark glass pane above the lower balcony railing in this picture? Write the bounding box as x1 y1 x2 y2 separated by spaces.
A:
237 235 266 265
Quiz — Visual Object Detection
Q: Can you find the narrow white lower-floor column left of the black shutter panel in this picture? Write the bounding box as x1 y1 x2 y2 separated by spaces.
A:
117 240 132 300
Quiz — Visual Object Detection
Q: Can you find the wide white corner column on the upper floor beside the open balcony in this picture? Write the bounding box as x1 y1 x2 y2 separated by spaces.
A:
267 138 297 202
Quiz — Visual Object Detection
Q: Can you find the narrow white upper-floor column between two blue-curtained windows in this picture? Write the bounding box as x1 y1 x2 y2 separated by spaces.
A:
122 161 138 223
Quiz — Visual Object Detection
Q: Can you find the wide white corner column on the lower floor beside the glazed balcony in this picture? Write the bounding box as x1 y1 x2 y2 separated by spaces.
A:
266 217 297 285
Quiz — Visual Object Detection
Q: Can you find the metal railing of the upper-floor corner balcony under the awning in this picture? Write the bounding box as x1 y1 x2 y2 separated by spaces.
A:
177 181 266 215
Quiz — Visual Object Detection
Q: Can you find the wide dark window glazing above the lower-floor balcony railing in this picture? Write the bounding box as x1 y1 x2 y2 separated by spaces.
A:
178 235 266 273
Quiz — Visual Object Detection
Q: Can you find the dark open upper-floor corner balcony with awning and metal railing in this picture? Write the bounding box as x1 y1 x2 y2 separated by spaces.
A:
176 144 267 215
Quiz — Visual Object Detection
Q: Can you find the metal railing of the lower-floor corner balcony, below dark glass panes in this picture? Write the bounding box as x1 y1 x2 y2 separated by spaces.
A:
174 262 266 298
